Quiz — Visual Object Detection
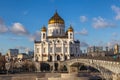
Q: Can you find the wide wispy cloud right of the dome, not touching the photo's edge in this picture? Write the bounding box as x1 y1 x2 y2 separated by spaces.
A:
93 17 115 29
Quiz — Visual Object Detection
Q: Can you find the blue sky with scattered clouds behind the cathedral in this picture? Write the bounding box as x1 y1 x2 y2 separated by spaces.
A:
0 0 120 54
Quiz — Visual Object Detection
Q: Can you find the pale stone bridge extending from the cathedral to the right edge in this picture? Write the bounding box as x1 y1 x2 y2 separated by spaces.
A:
40 57 120 80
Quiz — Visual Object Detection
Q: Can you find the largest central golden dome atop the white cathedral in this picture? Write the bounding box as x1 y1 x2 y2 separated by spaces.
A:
48 12 64 24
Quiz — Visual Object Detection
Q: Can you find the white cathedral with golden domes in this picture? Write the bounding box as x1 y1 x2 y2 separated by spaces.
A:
34 12 80 61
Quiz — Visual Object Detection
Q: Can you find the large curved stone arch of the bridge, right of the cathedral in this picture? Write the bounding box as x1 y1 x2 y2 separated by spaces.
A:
63 59 114 80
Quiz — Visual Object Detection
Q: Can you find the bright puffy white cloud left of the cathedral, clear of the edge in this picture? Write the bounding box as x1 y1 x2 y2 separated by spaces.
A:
10 23 28 35
